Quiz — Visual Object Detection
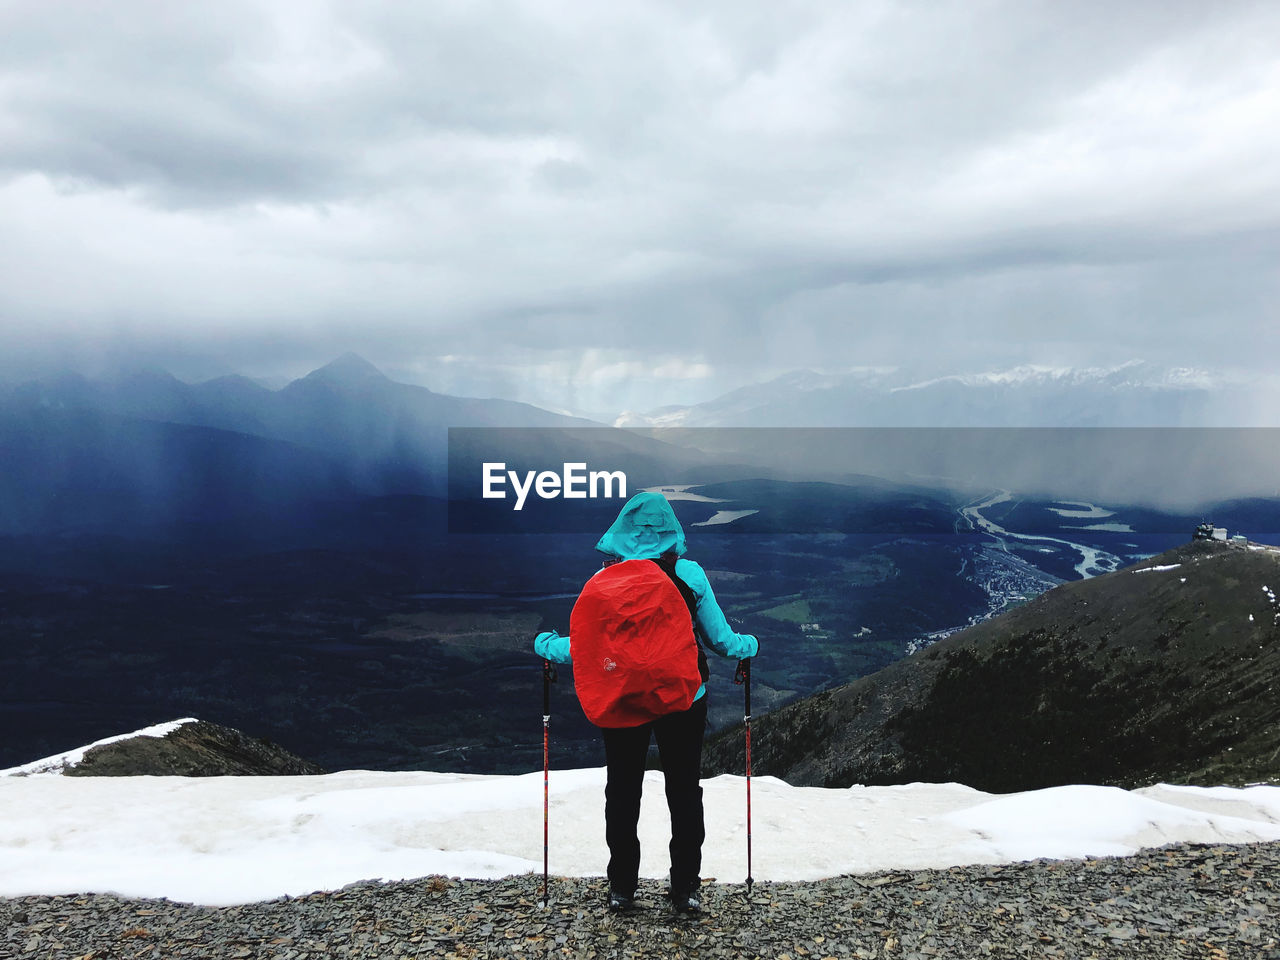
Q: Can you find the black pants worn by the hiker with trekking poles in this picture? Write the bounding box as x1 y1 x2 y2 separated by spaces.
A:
600 694 707 896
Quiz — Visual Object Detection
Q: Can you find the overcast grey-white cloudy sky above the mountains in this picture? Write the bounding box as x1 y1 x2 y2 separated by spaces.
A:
0 0 1280 410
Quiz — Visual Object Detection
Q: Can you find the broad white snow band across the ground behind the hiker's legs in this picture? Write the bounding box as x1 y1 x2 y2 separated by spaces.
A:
0 768 1280 905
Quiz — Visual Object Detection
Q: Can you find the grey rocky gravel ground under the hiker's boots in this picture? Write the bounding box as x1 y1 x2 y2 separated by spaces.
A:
0 844 1280 960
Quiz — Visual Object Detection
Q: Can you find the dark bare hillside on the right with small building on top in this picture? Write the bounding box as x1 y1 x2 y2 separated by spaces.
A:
705 541 1280 792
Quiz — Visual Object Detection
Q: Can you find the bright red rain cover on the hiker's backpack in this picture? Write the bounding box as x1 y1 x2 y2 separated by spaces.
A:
568 559 703 727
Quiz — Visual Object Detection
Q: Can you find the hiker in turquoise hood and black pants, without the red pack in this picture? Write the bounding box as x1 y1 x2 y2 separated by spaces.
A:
534 493 759 913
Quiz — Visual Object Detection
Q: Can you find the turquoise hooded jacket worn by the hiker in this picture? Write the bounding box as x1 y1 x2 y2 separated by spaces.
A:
534 493 760 700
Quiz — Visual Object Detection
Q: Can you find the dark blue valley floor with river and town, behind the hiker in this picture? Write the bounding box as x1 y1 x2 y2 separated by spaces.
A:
0 481 1249 772
